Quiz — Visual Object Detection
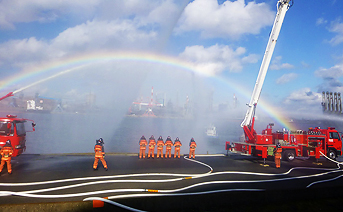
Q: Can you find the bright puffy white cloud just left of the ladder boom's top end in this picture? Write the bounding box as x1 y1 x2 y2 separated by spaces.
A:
177 0 275 39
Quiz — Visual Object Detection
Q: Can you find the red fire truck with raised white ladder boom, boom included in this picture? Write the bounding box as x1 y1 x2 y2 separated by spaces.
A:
226 0 342 161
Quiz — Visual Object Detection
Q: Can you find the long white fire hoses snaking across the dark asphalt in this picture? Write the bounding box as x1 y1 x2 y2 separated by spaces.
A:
0 155 343 210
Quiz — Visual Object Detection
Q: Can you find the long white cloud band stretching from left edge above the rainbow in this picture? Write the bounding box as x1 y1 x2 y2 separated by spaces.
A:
0 20 157 67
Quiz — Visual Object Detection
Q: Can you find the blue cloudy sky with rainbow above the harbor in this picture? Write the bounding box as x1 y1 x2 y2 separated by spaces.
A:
0 0 343 121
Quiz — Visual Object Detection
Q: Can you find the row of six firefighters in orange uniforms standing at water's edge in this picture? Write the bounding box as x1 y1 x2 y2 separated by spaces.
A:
139 135 197 158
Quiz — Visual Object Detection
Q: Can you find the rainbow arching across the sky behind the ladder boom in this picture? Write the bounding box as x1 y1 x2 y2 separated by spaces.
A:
0 51 296 129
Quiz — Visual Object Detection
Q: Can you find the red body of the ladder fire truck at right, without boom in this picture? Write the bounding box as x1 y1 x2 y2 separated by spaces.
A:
226 124 342 161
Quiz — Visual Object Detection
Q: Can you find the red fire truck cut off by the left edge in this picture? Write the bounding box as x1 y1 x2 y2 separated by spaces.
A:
0 92 36 157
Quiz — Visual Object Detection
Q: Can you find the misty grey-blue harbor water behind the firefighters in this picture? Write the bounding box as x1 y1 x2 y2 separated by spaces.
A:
0 112 343 154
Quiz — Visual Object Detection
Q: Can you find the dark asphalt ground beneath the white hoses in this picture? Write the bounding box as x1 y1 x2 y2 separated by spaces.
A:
0 154 343 211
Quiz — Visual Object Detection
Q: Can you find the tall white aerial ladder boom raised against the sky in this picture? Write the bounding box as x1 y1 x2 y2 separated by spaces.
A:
241 0 293 140
